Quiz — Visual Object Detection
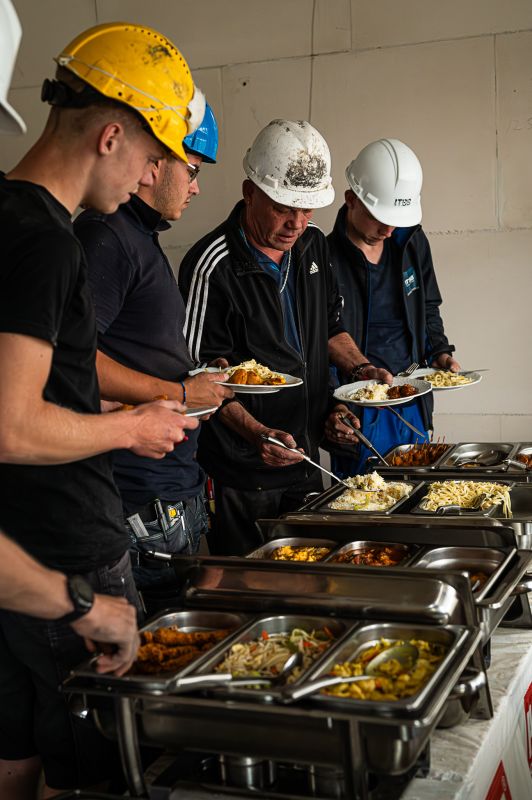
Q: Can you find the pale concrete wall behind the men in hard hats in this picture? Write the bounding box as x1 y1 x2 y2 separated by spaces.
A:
4 0 532 441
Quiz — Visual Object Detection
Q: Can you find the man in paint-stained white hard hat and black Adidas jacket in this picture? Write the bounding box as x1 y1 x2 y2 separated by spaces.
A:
179 119 385 555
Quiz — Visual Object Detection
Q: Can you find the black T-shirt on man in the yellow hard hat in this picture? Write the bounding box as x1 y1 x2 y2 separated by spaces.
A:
0 174 128 572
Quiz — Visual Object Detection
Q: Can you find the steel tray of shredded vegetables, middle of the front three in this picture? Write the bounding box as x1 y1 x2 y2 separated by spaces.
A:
187 614 354 700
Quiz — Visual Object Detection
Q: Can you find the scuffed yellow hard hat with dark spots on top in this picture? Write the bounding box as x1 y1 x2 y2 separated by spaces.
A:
55 22 205 161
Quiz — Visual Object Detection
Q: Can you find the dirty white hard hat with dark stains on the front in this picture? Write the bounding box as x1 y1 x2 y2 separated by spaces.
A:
244 119 334 208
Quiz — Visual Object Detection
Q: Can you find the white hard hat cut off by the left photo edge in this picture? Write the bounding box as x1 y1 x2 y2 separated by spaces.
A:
0 0 26 133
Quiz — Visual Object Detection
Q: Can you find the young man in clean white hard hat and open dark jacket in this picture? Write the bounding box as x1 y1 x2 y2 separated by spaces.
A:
327 139 460 476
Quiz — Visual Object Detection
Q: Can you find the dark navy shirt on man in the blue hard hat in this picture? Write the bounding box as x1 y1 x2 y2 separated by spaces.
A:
74 197 204 506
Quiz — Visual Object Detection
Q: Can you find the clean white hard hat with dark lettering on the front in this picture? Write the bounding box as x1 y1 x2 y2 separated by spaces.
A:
345 139 423 228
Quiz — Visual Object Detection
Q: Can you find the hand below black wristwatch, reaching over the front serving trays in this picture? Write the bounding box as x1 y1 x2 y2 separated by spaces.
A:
71 594 140 675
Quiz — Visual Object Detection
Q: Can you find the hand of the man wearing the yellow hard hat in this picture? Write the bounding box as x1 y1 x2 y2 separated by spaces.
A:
126 400 199 458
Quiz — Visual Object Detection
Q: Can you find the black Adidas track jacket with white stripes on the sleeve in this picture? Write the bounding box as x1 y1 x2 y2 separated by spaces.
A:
179 201 344 490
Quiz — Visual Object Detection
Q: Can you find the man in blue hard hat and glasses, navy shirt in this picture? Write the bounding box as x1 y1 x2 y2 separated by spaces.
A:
74 105 233 592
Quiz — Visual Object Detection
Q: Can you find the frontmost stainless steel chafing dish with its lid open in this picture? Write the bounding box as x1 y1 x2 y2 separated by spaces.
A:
65 557 491 800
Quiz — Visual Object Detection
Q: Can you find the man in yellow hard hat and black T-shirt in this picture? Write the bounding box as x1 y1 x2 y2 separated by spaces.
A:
0 18 205 800
